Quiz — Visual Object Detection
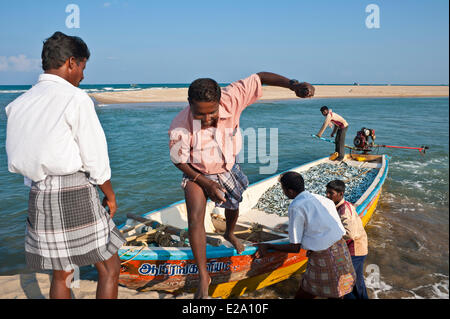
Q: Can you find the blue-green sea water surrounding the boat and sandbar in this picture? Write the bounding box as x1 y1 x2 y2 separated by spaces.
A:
0 85 449 298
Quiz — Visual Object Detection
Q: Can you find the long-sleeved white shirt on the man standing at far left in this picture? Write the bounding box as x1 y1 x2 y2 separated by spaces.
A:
5 74 111 184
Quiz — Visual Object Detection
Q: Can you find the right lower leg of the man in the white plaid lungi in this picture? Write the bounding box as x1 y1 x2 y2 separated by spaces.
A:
95 253 120 299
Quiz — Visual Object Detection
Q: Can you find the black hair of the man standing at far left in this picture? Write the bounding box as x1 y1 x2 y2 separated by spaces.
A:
41 31 91 71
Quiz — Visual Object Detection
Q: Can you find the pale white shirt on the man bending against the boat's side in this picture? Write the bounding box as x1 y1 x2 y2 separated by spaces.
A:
288 191 345 251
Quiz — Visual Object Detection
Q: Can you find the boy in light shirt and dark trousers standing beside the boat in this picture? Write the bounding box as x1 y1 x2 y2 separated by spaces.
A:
327 180 369 299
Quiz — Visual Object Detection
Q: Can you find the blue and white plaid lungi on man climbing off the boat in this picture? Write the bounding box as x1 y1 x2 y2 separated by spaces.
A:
181 163 249 210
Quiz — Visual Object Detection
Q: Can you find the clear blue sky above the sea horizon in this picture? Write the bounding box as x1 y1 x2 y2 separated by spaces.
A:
0 0 449 85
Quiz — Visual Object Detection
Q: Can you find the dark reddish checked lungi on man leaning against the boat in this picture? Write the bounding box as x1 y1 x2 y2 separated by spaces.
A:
300 239 356 298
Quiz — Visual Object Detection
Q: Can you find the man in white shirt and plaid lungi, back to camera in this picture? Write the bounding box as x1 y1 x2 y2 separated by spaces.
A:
6 32 125 298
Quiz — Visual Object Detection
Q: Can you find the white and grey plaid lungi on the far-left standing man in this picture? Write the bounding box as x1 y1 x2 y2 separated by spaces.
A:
25 172 125 271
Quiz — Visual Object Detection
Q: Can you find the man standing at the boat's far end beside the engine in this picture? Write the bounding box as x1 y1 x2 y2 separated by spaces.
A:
317 106 348 161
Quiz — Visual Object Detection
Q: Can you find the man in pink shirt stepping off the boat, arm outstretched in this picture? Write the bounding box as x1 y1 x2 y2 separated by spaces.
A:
169 72 314 298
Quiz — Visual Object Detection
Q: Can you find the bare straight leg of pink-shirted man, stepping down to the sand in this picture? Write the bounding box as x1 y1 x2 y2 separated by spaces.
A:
184 181 211 299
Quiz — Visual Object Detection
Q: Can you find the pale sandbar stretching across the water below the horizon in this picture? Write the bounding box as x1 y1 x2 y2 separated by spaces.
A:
90 85 449 104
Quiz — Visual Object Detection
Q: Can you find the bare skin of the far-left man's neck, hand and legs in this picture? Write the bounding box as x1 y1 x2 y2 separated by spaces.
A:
45 57 120 299
